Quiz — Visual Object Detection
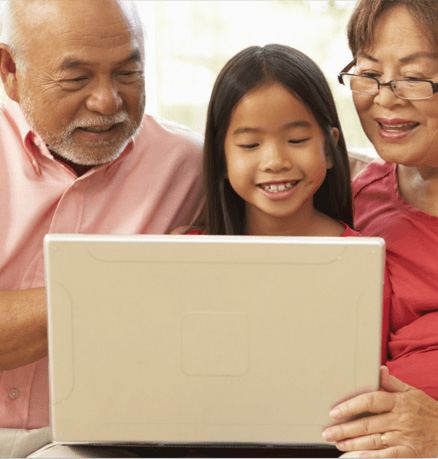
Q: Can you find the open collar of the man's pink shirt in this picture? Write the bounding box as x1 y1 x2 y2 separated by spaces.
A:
5 98 134 176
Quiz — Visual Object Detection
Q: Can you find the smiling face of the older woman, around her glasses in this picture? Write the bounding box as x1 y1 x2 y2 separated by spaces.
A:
353 6 438 167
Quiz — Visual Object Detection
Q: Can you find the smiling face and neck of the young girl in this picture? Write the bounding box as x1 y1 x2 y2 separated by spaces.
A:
225 83 338 234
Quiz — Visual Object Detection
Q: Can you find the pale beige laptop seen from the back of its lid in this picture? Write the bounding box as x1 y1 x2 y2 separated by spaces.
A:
44 234 385 445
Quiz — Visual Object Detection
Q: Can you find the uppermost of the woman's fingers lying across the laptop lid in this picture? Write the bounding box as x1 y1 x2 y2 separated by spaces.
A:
330 392 396 421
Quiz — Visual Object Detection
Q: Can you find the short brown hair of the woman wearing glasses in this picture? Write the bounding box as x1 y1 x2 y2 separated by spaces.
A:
347 0 438 57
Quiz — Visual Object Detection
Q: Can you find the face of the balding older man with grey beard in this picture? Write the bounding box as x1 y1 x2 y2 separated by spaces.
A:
17 0 145 165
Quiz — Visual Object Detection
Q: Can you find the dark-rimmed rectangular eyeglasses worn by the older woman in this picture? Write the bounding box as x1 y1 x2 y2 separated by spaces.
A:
338 60 438 100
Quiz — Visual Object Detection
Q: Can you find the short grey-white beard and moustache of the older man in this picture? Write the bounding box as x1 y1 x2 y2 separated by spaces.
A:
20 95 140 166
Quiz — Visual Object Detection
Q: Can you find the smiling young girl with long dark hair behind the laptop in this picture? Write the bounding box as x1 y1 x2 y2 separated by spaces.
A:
190 44 357 236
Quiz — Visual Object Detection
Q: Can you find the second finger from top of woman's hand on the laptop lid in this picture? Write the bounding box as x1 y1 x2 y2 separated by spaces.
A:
322 413 396 441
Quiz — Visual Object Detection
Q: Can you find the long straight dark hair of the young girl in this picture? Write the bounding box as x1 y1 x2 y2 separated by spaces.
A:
200 44 353 234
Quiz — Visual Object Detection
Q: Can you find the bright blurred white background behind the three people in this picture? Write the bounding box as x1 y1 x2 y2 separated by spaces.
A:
0 0 370 150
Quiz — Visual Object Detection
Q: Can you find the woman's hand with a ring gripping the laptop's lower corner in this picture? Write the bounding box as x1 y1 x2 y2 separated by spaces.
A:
323 367 438 457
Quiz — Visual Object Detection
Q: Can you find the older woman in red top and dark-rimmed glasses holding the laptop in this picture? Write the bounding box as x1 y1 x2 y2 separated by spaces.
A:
324 0 438 457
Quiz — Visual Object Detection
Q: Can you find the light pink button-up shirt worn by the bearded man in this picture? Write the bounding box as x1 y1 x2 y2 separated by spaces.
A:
0 101 202 429
